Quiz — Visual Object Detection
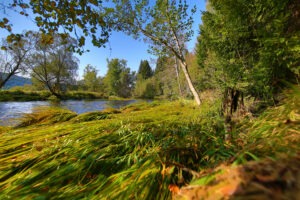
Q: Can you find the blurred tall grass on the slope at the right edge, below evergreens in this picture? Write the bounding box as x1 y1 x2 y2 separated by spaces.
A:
235 86 300 162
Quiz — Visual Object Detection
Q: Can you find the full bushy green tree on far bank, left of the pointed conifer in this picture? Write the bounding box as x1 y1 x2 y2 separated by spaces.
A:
104 58 134 97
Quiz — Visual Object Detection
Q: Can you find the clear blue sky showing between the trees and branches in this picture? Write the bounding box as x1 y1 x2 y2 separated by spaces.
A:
0 0 205 78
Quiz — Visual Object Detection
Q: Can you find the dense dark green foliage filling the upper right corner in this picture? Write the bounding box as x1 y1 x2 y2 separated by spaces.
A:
197 0 299 100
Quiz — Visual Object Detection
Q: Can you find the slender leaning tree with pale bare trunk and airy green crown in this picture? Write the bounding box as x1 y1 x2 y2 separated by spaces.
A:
112 0 201 105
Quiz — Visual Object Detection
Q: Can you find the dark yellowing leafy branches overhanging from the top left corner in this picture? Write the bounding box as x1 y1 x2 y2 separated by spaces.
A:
0 0 112 53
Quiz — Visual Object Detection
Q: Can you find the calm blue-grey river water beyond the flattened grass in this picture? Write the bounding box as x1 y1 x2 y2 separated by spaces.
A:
0 100 137 125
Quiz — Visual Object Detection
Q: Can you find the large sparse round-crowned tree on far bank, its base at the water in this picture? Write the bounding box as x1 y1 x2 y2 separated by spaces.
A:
29 33 78 98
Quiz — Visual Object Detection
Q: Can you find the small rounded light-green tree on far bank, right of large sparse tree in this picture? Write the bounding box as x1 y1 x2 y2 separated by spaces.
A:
83 65 101 92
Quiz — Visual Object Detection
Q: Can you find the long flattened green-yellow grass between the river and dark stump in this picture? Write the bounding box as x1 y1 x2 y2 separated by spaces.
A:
0 99 228 199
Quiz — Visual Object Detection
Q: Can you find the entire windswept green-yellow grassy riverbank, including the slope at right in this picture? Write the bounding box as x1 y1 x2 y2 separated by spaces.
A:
0 88 300 199
